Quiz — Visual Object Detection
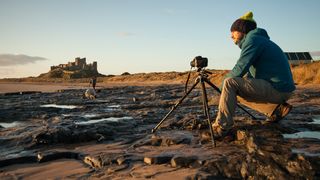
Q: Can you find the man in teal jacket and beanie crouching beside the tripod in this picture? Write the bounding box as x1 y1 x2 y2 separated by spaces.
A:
212 12 295 138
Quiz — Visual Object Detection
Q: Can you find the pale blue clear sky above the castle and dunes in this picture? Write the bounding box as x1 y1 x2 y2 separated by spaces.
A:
0 0 320 78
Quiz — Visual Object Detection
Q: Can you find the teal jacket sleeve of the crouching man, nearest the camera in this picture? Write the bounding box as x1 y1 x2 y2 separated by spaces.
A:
227 41 260 77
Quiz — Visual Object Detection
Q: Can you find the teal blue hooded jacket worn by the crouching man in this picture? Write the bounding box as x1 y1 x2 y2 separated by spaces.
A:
227 28 295 92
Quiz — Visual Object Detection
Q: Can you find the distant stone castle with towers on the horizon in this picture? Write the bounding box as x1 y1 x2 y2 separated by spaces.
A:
51 57 98 72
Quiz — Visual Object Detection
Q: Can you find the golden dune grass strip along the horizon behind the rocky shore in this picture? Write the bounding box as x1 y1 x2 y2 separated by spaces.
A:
0 61 320 86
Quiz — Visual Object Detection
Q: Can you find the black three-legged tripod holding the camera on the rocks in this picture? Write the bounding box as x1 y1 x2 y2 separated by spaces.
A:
151 68 256 146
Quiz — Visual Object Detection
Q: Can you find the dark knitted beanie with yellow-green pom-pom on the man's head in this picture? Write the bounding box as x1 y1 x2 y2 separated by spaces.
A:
230 11 257 34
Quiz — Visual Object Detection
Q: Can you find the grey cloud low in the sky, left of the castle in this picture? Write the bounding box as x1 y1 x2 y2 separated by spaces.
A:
0 54 47 66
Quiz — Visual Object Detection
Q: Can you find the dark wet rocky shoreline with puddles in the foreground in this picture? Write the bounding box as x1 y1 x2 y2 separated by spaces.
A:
0 85 320 179
